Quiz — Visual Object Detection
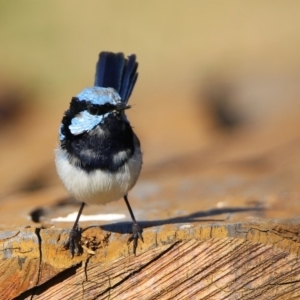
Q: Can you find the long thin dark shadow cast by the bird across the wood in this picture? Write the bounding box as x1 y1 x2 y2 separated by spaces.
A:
83 207 265 234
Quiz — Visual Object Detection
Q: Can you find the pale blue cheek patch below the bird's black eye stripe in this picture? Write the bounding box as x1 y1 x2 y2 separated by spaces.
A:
69 110 108 135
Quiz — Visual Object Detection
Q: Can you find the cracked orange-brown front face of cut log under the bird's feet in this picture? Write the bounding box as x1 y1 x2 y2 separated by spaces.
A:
0 219 300 300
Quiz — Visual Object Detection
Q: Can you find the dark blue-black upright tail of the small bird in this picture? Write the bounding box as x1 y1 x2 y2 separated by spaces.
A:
95 52 138 103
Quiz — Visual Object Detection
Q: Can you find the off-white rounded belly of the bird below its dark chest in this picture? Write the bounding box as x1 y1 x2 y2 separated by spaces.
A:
55 148 142 204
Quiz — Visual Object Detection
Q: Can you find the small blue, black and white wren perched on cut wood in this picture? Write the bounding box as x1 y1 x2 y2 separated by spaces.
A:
55 51 144 257
